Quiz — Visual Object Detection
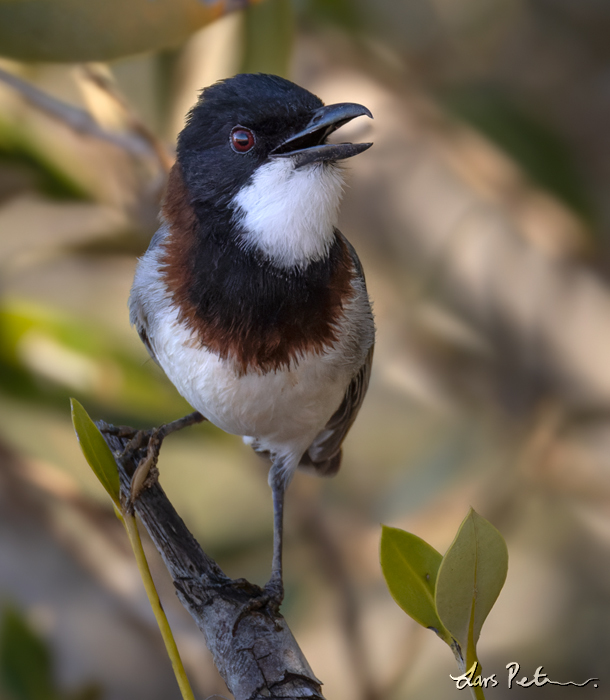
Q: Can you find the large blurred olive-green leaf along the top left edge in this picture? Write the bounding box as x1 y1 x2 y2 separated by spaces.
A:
0 0 258 62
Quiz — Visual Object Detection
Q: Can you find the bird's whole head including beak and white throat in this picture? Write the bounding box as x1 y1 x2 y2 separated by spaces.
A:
173 74 372 267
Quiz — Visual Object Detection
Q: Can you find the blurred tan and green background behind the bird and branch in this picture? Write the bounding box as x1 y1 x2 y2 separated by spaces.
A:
0 0 610 700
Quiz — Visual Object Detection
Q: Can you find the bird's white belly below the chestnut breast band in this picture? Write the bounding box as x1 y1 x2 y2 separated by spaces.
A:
154 308 357 459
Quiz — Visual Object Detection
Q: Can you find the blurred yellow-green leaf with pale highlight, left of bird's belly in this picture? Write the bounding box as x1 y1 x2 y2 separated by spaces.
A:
0 300 189 424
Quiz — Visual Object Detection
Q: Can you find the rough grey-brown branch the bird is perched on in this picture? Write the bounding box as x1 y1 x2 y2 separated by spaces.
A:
97 421 323 700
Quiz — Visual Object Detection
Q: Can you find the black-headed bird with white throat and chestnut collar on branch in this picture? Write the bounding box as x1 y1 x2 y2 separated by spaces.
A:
129 73 375 609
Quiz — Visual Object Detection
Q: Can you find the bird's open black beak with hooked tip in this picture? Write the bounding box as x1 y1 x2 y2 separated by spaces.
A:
270 102 373 168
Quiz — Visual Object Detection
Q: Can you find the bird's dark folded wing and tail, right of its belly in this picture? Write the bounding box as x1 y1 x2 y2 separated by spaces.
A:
299 345 375 476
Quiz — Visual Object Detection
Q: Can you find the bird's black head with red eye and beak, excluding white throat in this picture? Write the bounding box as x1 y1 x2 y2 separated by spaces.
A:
173 73 371 208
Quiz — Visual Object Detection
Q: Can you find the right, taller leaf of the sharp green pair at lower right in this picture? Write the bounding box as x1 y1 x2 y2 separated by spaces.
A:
436 508 508 667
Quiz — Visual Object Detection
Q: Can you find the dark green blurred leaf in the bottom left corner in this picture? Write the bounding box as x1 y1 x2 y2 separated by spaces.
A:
0 607 58 700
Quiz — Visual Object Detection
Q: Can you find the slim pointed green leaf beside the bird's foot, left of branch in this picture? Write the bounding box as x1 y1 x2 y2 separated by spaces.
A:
70 399 120 510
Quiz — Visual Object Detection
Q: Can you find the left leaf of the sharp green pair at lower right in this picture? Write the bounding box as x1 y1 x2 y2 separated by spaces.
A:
381 525 452 644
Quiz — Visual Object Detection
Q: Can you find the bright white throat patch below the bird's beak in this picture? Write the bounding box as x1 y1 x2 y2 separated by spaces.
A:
232 158 343 268
